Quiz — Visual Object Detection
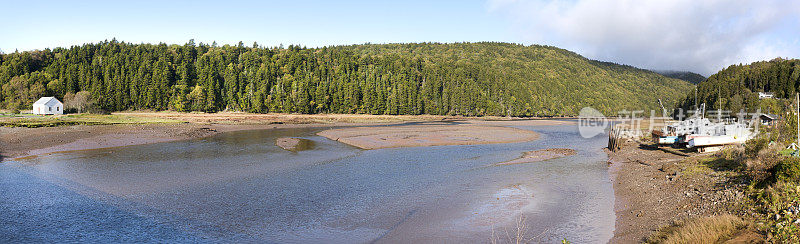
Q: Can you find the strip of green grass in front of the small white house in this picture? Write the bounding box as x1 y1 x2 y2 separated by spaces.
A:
0 114 183 128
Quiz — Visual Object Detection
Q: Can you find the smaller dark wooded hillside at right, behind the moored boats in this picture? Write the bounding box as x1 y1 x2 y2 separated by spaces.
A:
679 58 800 112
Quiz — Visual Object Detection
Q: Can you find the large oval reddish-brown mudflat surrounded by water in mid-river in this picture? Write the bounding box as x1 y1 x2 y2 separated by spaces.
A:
317 123 538 149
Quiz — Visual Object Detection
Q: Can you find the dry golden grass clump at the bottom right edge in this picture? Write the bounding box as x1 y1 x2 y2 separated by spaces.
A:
647 215 747 243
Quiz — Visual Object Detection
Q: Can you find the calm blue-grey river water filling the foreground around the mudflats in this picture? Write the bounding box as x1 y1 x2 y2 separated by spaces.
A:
0 125 615 243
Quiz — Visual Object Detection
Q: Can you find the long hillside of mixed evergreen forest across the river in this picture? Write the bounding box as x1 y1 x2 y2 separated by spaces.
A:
0 40 692 116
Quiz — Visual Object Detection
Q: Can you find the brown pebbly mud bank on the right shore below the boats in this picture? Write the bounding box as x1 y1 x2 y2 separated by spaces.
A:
607 142 746 243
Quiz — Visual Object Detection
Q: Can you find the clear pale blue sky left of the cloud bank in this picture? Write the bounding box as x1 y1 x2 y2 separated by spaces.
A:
0 0 519 52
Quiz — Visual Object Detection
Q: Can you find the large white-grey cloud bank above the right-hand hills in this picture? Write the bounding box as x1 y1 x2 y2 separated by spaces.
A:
487 0 800 75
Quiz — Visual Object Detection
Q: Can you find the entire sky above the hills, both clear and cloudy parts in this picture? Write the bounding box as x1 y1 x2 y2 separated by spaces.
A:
0 0 800 75
